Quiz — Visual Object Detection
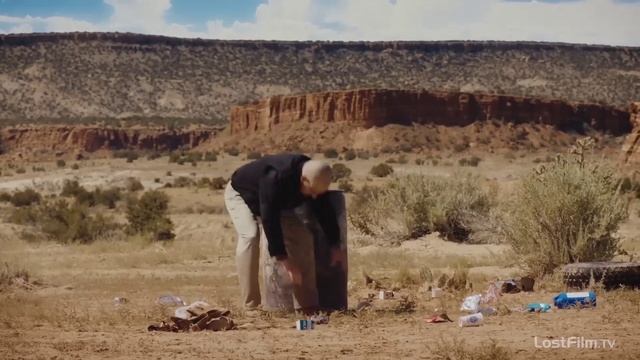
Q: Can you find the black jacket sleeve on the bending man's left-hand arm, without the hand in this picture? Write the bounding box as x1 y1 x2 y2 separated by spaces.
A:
259 170 287 260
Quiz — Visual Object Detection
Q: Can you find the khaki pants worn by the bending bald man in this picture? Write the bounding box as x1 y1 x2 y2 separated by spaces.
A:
224 182 318 310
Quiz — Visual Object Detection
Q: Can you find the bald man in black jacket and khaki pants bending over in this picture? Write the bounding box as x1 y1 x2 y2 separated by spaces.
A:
225 154 343 312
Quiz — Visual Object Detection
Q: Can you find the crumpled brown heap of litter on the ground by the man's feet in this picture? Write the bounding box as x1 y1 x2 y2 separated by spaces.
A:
147 309 236 332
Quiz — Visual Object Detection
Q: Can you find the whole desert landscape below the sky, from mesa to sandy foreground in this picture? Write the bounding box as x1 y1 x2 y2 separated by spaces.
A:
0 33 640 359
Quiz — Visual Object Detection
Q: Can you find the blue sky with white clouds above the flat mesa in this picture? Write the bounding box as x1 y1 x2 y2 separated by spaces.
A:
0 0 640 46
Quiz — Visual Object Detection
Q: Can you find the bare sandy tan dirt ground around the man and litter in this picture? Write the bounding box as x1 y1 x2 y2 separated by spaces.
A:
0 155 640 359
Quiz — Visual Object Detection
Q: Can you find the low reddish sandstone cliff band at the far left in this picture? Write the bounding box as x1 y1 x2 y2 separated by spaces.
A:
0 126 219 155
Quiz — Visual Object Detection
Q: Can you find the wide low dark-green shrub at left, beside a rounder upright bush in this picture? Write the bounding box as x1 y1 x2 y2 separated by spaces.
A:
9 199 118 243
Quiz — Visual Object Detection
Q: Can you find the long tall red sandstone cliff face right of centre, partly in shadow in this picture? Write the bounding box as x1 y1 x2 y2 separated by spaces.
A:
230 89 631 135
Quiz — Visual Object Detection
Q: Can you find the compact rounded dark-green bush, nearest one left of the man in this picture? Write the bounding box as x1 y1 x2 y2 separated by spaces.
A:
127 190 175 240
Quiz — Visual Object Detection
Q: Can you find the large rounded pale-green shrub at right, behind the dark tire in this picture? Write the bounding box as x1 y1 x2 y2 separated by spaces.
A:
503 139 629 274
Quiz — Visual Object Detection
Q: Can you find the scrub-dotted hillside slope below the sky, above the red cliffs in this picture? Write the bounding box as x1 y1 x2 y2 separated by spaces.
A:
0 33 640 123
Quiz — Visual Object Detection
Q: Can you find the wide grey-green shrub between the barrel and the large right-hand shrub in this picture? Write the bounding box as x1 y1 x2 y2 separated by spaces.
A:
349 174 496 241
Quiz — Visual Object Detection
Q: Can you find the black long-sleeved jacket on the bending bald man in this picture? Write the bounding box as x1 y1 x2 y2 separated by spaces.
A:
231 154 340 259
